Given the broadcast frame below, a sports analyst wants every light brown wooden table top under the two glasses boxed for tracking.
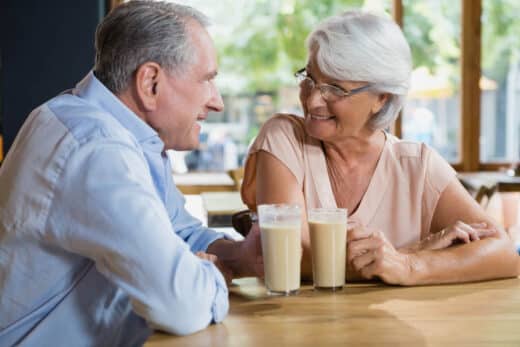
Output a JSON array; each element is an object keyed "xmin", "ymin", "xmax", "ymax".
[{"xmin": 145, "ymin": 278, "xmax": 520, "ymax": 347}]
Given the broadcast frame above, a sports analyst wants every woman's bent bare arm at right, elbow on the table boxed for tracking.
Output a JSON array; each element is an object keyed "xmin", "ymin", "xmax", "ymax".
[{"xmin": 412, "ymin": 178, "xmax": 519, "ymax": 284}]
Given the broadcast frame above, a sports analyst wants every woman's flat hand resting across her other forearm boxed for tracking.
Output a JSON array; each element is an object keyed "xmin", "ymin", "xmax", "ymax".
[{"xmin": 406, "ymin": 221, "xmax": 498, "ymax": 252}]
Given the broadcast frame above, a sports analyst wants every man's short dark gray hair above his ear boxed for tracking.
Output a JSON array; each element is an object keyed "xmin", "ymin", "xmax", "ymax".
[{"xmin": 94, "ymin": 1, "xmax": 208, "ymax": 94}]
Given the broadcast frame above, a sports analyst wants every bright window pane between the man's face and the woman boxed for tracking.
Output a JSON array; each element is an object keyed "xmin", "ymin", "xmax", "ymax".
[{"xmin": 168, "ymin": 0, "xmax": 392, "ymax": 171}]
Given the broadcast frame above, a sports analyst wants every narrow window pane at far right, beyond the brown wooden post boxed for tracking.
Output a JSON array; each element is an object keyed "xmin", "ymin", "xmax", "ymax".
[{"xmin": 480, "ymin": 0, "xmax": 520, "ymax": 163}]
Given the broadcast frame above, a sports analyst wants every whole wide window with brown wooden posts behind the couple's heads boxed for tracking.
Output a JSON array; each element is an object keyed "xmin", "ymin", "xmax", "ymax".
[{"xmin": 116, "ymin": 0, "xmax": 520, "ymax": 171}]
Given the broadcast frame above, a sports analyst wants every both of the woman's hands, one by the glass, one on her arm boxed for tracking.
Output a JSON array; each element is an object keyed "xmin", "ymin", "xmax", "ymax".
[{"xmin": 347, "ymin": 221, "xmax": 498, "ymax": 285}]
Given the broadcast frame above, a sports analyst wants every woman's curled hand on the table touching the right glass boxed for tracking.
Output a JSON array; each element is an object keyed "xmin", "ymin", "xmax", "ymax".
[{"xmin": 347, "ymin": 226, "xmax": 413, "ymax": 285}]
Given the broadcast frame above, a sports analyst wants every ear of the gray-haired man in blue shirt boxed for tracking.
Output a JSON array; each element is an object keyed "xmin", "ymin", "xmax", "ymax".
[{"xmin": 135, "ymin": 62, "xmax": 161, "ymax": 111}]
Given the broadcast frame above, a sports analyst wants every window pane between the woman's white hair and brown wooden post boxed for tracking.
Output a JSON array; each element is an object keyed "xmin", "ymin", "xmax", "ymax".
[{"xmin": 402, "ymin": 0, "xmax": 461, "ymax": 163}]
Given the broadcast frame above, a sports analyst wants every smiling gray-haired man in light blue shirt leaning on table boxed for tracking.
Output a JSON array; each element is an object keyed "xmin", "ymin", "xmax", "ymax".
[{"xmin": 0, "ymin": 1, "xmax": 262, "ymax": 346}]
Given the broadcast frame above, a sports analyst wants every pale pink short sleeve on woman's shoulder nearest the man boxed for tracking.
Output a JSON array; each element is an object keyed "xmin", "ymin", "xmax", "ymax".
[{"xmin": 241, "ymin": 114, "xmax": 305, "ymax": 210}]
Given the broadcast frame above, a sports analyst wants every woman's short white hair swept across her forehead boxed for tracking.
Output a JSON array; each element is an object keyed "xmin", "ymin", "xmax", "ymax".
[{"xmin": 307, "ymin": 11, "xmax": 412, "ymax": 129}]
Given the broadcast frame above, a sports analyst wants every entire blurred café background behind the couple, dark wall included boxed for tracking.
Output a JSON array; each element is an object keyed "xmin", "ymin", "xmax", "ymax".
[{"xmin": 0, "ymin": 0, "xmax": 520, "ymax": 231}]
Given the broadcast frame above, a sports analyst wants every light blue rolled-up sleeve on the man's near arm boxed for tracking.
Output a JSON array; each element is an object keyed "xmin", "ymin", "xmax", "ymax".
[{"xmin": 46, "ymin": 140, "xmax": 229, "ymax": 335}]
